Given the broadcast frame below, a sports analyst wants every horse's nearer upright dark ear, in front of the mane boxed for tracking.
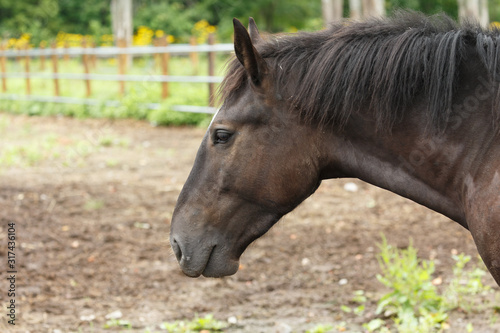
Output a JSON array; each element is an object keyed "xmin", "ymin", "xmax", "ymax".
[{"xmin": 233, "ymin": 18, "xmax": 267, "ymax": 86}]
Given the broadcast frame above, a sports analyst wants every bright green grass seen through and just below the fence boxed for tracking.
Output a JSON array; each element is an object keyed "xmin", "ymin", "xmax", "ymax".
[{"xmin": 0, "ymin": 55, "xmax": 228, "ymax": 125}]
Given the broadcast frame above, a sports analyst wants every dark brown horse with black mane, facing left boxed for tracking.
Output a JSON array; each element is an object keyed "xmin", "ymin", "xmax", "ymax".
[{"xmin": 170, "ymin": 13, "xmax": 500, "ymax": 283}]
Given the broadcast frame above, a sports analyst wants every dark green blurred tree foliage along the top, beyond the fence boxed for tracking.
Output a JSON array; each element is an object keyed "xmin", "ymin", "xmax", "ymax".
[{"xmin": 4, "ymin": 0, "xmax": 500, "ymax": 44}]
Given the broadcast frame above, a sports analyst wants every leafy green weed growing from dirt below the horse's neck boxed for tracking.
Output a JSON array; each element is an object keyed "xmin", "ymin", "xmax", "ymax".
[{"xmin": 372, "ymin": 237, "xmax": 488, "ymax": 333}]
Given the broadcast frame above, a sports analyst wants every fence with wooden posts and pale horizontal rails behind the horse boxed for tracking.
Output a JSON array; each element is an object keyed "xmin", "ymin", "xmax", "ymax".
[{"xmin": 0, "ymin": 35, "xmax": 234, "ymax": 113}]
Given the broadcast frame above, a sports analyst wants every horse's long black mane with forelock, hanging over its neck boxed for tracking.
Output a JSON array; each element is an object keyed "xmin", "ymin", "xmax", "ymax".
[{"xmin": 220, "ymin": 12, "xmax": 500, "ymax": 128}]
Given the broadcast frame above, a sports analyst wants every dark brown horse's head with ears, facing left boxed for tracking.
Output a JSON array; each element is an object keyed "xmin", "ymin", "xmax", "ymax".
[{"xmin": 170, "ymin": 19, "xmax": 321, "ymax": 277}]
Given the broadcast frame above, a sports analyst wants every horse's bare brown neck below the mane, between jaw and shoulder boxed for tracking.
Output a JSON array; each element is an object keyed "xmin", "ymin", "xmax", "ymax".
[{"xmin": 327, "ymin": 103, "xmax": 500, "ymax": 227}]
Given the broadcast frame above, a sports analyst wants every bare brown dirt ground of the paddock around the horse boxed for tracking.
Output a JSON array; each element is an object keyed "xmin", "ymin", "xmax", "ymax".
[{"xmin": 0, "ymin": 113, "xmax": 500, "ymax": 333}]
